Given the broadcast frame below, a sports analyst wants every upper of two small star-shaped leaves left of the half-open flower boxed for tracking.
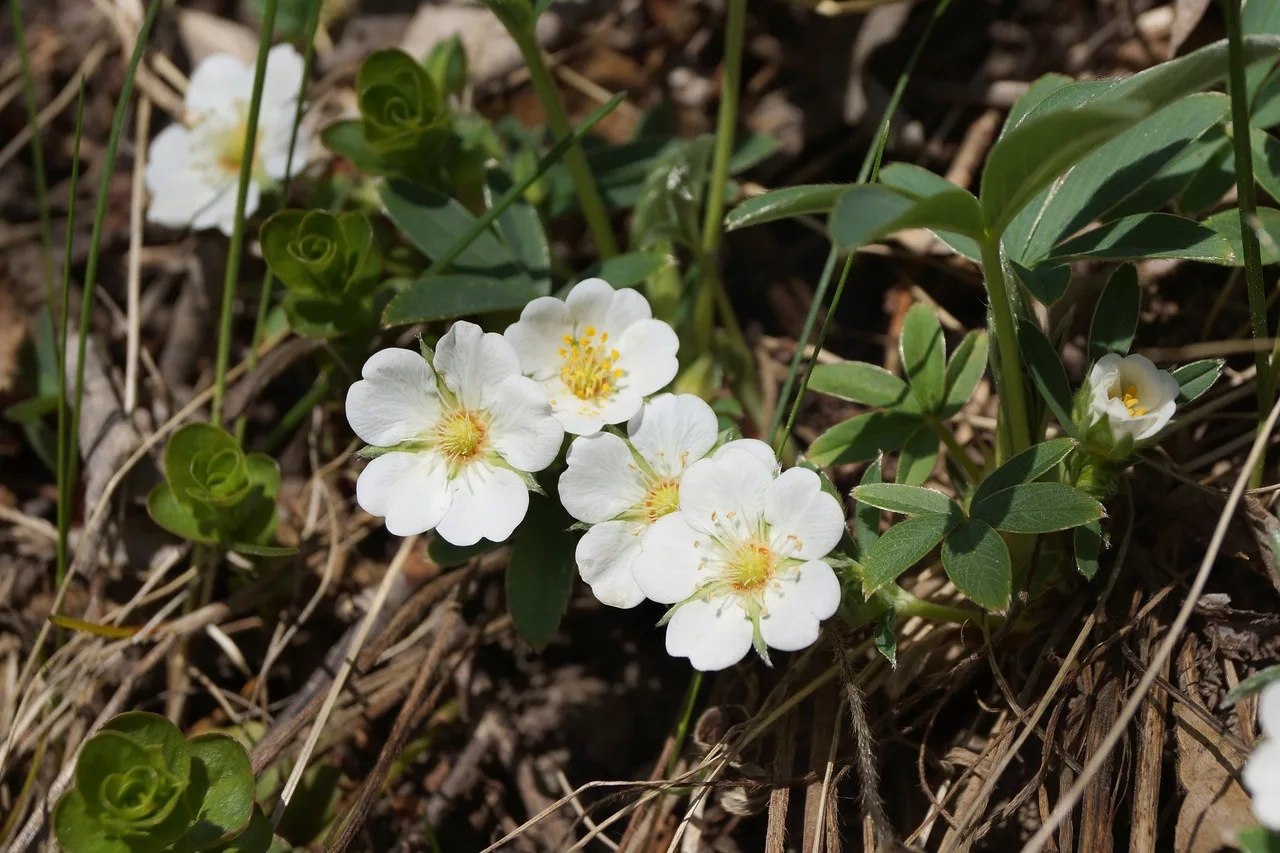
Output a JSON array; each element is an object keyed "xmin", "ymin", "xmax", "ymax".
[{"xmin": 809, "ymin": 305, "xmax": 987, "ymax": 485}]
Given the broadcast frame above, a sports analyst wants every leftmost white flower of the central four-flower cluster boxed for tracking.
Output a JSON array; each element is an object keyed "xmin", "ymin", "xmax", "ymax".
[{"xmin": 347, "ymin": 323, "xmax": 564, "ymax": 546}]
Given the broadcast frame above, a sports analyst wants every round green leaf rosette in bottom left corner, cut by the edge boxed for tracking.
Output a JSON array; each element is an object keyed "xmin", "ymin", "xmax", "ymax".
[{"xmin": 54, "ymin": 711, "xmax": 264, "ymax": 853}]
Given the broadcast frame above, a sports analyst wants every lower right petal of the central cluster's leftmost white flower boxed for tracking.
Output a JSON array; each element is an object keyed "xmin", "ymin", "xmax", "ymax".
[{"xmin": 435, "ymin": 462, "xmax": 529, "ymax": 546}]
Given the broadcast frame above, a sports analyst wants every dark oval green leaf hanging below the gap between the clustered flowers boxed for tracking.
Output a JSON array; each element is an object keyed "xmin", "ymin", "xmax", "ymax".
[{"xmin": 507, "ymin": 494, "xmax": 576, "ymax": 649}]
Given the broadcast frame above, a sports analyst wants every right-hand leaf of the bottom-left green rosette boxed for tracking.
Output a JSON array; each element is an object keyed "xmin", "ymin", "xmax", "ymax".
[{"xmin": 173, "ymin": 734, "xmax": 253, "ymax": 853}]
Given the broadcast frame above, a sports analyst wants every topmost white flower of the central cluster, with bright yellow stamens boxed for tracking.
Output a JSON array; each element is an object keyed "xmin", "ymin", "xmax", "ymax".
[{"xmin": 506, "ymin": 278, "xmax": 680, "ymax": 435}]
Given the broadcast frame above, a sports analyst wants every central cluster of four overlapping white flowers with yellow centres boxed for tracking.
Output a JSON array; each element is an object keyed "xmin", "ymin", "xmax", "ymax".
[{"xmin": 347, "ymin": 279, "xmax": 845, "ymax": 670}]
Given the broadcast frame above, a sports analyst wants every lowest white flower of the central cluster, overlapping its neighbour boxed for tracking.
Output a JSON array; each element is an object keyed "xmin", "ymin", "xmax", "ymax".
[{"xmin": 634, "ymin": 439, "xmax": 845, "ymax": 670}]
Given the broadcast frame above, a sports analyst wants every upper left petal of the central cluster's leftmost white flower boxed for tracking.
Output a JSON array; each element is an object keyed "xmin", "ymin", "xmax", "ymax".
[{"xmin": 347, "ymin": 348, "xmax": 440, "ymax": 447}]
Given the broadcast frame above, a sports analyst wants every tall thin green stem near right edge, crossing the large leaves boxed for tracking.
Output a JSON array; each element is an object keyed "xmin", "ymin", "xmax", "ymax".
[{"xmin": 1222, "ymin": 0, "xmax": 1276, "ymax": 488}]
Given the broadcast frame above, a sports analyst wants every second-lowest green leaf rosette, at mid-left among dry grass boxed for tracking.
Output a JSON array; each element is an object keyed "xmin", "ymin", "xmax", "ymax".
[{"xmin": 147, "ymin": 424, "xmax": 285, "ymax": 556}]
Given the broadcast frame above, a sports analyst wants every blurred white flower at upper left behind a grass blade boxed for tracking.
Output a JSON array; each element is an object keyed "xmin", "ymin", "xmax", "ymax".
[{"xmin": 146, "ymin": 45, "xmax": 306, "ymax": 234}]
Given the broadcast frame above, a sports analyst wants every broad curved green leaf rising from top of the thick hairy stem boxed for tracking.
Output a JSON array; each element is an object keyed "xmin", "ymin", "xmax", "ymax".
[{"xmin": 978, "ymin": 104, "xmax": 1143, "ymax": 234}]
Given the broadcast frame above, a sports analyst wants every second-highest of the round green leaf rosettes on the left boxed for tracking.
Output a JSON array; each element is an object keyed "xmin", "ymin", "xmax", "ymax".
[{"xmin": 260, "ymin": 210, "xmax": 381, "ymax": 338}]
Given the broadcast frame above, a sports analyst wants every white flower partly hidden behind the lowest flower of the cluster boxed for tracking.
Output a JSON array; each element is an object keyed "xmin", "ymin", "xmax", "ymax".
[{"xmin": 559, "ymin": 394, "xmax": 719, "ymax": 607}]
